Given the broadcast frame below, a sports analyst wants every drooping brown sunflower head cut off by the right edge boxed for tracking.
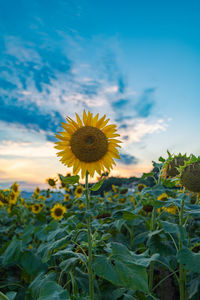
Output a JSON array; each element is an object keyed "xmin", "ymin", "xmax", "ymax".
[{"xmin": 179, "ymin": 155, "xmax": 200, "ymax": 193}]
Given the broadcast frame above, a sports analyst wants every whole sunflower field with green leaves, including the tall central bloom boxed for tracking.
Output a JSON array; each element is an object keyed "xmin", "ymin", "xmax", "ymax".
[{"xmin": 0, "ymin": 113, "xmax": 200, "ymax": 300}]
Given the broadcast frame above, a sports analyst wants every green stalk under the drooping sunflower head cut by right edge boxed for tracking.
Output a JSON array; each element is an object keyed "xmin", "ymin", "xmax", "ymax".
[{"xmin": 179, "ymin": 199, "xmax": 185, "ymax": 300}]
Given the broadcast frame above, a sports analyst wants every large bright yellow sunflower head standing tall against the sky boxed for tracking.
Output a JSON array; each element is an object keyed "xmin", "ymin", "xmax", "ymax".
[{"xmin": 55, "ymin": 110, "xmax": 120, "ymax": 178}]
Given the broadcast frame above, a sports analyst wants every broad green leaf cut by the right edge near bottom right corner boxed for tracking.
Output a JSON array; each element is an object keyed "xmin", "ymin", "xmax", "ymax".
[{"xmin": 177, "ymin": 248, "xmax": 200, "ymax": 274}]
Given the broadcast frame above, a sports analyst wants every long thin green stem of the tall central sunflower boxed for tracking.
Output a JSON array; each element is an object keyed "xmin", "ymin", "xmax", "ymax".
[{"xmin": 85, "ymin": 171, "xmax": 94, "ymax": 300}]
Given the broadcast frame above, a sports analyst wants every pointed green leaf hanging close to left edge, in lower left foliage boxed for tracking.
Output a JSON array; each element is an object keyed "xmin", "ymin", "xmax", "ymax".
[{"xmin": 2, "ymin": 236, "xmax": 21, "ymax": 266}]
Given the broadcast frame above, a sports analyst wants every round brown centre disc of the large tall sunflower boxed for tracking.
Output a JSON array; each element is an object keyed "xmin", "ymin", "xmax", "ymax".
[{"xmin": 70, "ymin": 126, "xmax": 108, "ymax": 162}]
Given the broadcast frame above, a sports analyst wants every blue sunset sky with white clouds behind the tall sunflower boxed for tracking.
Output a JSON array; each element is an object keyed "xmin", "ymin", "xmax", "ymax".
[{"xmin": 0, "ymin": 0, "xmax": 200, "ymax": 189}]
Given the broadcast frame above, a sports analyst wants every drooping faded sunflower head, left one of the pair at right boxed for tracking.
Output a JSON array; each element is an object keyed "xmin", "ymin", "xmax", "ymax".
[{"xmin": 161, "ymin": 152, "xmax": 189, "ymax": 179}]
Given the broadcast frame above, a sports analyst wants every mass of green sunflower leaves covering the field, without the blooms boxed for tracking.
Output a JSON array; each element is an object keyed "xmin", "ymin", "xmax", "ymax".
[{"xmin": 0, "ymin": 163, "xmax": 200, "ymax": 300}]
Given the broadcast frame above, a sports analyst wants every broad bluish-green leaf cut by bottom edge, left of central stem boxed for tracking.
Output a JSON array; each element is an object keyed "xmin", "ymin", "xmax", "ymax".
[{"xmin": 38, "ymin": 281, "xmax": 70, "ymax": 300}]
